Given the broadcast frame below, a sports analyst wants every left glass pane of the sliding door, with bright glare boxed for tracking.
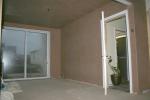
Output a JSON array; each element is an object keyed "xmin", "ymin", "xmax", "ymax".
[{"xmin": 2, "ymin": 29, "xmax": 25, "ymax": 79}]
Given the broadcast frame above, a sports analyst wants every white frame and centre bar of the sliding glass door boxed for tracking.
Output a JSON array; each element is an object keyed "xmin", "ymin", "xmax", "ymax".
[{"xmin": 3, "ymin": 26, "xmax": 51, "ymax": 81}]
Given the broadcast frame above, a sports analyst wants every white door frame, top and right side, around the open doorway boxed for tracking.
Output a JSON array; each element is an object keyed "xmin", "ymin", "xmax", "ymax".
[{"xmin": 102, "ymin": 10, "xmax": 133, "ymax": 94}]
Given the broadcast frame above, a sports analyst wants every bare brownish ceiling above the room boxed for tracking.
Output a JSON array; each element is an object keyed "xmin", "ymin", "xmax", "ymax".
[{"xmin": 4, "ymin": 0, "xmax": 111, "ymax": 27}]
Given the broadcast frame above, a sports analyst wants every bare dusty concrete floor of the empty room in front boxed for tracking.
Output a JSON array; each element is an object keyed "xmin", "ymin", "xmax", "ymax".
[{"xmin": 15, "ymin": 79, "xmax": 150, "ymax": 100}]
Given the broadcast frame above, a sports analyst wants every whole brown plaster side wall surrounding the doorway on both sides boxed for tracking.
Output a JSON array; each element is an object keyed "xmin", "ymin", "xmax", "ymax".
[{"xmin": 61, "ymin": 0, "xmax": 150, "ymax": 93}]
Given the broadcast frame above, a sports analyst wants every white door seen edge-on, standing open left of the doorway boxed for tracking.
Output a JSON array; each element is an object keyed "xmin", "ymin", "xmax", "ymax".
[{"xmin": 101, "ymin": 11, "xmax": 108, "ymax": 95}]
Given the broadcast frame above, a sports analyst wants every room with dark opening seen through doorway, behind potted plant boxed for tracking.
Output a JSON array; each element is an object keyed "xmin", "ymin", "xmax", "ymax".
[{"xmin": 106, "ymin": 16, "xmax": 129, "ymax": 91}]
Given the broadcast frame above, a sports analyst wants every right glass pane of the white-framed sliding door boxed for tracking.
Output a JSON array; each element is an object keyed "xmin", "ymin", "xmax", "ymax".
[{"xmin": 26, "ymin": 32, "xmax": 47, "ymax": 78}]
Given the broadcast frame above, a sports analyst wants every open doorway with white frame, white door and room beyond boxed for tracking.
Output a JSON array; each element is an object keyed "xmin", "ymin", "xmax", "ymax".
[{"xmin": 101, "ymin": 10, "xmax": 133, "ymax": 94}]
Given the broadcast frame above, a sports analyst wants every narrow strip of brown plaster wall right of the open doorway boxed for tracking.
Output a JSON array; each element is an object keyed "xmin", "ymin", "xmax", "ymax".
[{"xmin": 130, "ymin": 0, "xmax": 150, "ymax": 92}]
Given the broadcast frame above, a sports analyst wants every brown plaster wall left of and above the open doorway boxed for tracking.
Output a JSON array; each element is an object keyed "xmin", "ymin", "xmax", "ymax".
[{"xmin": 62, "ymin": 2, "xmax": 125, "ymax": 85}]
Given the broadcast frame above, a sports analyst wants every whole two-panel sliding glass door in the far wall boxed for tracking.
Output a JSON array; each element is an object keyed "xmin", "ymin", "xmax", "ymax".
[{"xmin": 2, "ymin": 28, "xmax": 49, "ymax": 79}]
